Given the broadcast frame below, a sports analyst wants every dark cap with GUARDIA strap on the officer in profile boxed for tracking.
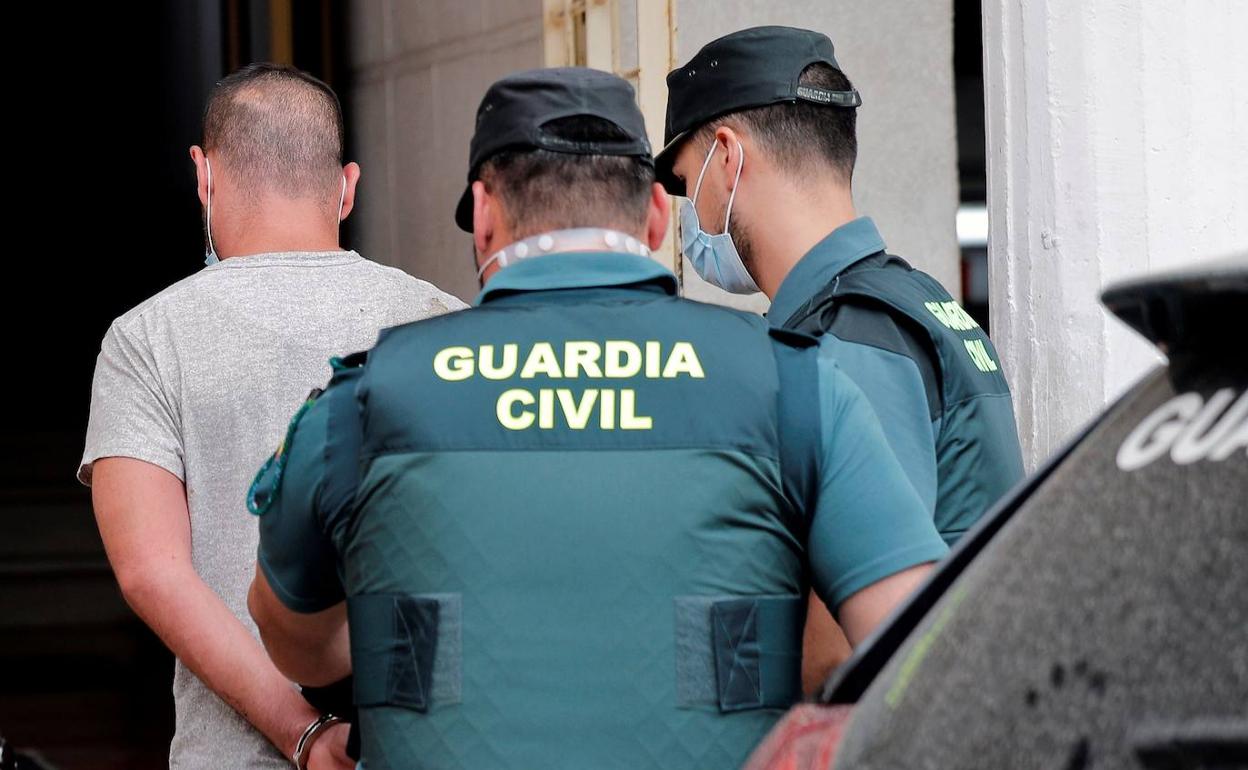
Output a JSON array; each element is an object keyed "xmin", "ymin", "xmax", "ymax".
[{"xmin": 654, "ymin": 26, "xmax": 862, "ymax": 195}]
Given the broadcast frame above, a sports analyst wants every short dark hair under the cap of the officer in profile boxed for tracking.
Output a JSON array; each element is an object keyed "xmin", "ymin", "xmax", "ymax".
[{"xmin": 698, "ymin": 62, "xmax": 857, "ymax": 185}]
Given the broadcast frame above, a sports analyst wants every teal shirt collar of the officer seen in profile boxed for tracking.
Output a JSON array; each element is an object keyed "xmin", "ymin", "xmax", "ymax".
[{"xmin": 768, "ymin": 217, "xmax": 885, "ymax": 326}]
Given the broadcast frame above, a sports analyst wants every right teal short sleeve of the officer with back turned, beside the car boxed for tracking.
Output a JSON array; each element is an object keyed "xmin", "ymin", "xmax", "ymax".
[{"xmin": 809, "ymin": 356, "xmax": 947, "ymax": 608}]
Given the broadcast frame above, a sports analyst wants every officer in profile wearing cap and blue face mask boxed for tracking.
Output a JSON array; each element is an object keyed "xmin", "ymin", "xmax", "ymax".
[{"xmin": 655, "ymin": 26, "xmax": 1022, "ymax": 686}]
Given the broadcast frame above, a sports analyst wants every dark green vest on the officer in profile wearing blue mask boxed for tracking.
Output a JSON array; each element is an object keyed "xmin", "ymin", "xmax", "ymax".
[{"xmin": 784, "ymin": 252, "xmax": 1023, "ymax": 539}]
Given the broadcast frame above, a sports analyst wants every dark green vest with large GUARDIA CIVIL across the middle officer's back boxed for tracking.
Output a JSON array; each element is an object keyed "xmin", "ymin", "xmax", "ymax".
[{"xmin": 342, "ymin": 288, "xmax": 814, "ymax": 770}]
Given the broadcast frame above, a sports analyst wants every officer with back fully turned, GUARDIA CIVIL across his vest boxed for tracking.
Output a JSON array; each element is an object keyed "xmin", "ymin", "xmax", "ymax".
[{"xmin": 250, "ymin": 69, "xmax": 945, "ymax": 770}]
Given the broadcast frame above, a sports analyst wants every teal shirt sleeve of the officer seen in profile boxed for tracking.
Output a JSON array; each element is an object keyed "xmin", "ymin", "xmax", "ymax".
[{"xmin": 820, "ymin": 334, "xmax": 937, "ymax": 517}]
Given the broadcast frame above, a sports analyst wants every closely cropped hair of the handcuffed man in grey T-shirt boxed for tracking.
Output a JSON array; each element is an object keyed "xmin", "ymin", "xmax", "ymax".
[{"xmin": 203, "ymin": 62, "xmax": 343, "ymax": 197}]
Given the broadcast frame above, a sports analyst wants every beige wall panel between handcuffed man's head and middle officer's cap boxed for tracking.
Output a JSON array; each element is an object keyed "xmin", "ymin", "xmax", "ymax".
[{"xmin": 348, "ymin": 0, "xmax": 542, "ymax": 300}]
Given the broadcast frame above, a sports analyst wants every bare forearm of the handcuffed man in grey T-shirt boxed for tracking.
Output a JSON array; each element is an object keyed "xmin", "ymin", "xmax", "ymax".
[{"xmin": 119, "ymin": 565, "xmax": 317, "ymax": 756}]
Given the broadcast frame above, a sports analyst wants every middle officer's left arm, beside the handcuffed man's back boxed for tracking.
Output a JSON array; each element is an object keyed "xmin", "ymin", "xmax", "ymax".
[{"xmin": 247, "ymin": 382, "xmax": 353, "ymax": 686}]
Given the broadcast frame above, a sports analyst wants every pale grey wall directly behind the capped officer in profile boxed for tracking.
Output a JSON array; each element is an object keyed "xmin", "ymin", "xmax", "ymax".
[{"xmin": 676, "ymin": 0, "xmax": 961, "ymax": 312}]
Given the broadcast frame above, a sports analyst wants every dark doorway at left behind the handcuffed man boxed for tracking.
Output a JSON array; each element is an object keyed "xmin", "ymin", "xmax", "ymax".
[{"xmin": 0, "ymin": 0, "xmax": 346, "ymax": 770}]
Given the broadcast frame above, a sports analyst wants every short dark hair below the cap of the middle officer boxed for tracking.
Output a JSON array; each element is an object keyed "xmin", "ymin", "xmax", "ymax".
[{"xmin": 479, "ymin": 116, "xmax": 654, "ymax": 238}]
